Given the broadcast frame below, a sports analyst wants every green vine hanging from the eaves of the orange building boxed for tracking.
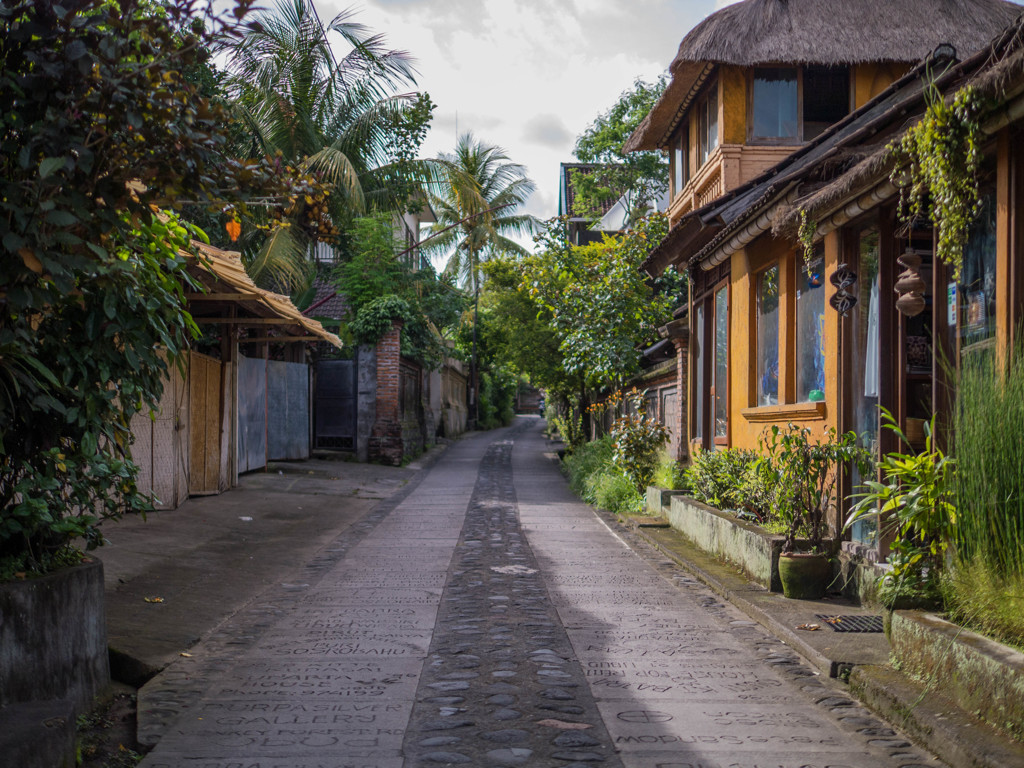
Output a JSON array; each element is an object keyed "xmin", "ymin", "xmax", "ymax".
[{"xmin": 889, "ymin": 83, "xmax": 983, "ymax": 281}]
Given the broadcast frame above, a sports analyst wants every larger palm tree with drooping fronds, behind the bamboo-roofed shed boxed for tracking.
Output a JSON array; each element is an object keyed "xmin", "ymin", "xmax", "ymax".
[{"xmin": 227, "ymin": 0, "xmax": 429, "ymax": 289}]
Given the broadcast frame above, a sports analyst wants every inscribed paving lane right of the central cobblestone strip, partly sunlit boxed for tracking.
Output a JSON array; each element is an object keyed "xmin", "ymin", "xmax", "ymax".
[{"xmin": 513, "ymin": 417, "xmax": 938, "ymax": 768}]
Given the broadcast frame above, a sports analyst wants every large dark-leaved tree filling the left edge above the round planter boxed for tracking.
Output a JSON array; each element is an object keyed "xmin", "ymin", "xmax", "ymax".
[{"xmin": 0, "ymin": 0, "xmax": 272, "ymax": 569}]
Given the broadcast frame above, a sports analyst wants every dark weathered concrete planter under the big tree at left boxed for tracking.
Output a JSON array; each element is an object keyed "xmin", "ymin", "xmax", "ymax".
[{"xmin": 0, "ymin": 559, "xmax": 111, "ymax": 713}]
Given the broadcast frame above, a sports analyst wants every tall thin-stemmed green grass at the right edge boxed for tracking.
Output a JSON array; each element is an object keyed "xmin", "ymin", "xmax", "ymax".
[{"xmin": 952, "ymin": 343, "xmax": 1024, "ymax": 579}]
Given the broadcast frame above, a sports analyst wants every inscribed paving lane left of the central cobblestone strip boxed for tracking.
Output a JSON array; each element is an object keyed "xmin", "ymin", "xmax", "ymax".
[{"xmin": 140, "ymin": 435, "xmax": 493, "ymax": 768}]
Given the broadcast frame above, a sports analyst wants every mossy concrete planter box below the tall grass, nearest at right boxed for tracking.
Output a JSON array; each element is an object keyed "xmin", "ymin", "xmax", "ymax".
[{"xmin": 889, "ymin": 610, "xmax": 1024, "ymax": 741}]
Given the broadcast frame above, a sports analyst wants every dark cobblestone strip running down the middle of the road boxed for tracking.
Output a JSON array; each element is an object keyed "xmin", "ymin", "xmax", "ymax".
[{"xmin": 404, "ymin": 428, "xmax": 622, "ymax": 768}]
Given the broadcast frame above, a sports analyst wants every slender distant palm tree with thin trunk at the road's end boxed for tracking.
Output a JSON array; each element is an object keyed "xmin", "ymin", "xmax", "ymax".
[{"xmin": 423, "ymin": 133, "xmax": 540, "ymax": 430}]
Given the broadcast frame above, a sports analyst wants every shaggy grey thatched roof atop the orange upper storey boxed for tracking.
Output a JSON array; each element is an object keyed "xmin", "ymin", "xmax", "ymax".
[{"xmin": 626, "ymin": 0, "xmax": 1024, "ymax": 152}]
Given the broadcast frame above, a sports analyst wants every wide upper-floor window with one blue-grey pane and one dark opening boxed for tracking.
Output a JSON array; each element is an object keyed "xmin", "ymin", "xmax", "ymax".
[{"xmin": 749, "ymin": 67, "xmax": 850, "ymax": 142}]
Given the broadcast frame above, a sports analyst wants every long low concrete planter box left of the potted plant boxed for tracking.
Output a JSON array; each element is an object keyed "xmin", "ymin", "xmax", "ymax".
[{"xmin": 668, "ymin": 496, "xmax": 833, "ymax": 592}]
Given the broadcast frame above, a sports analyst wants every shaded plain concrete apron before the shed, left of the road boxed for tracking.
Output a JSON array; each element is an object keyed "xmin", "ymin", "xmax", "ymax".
[{"xmin": 95, "ymin": 445, "xmax": 444, "ymax": 687}]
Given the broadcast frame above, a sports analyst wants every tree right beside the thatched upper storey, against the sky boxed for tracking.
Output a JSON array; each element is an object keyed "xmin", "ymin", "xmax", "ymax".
[{"xmin": 571, "ymin": 75, "xmax": 669, "ymax": 222}]
